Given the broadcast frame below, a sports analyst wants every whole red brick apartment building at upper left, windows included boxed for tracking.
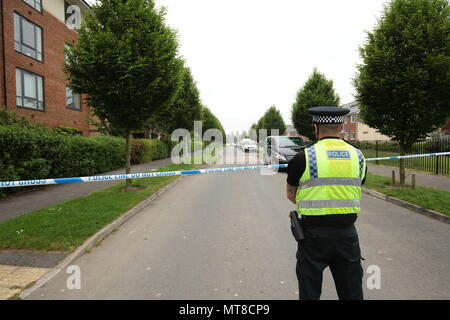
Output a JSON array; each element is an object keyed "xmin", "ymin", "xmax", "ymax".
[{"xmin": 0, "ymin": 0, "xmax": 96, "ymax": 136}]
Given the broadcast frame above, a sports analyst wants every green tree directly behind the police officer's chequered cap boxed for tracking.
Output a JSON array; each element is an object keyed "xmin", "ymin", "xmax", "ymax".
[{"xmin": 291, "ymin": 68, "xmax": 340, "ymax": 140}]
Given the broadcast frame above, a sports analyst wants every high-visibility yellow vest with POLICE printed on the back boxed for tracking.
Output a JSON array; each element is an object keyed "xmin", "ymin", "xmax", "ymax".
[{"xmin": 296, "ymin": 138, "xmax": 366, "ymax": 216}]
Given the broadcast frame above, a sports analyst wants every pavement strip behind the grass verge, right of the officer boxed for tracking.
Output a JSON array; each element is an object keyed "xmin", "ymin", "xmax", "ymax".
[{"xmin": 367, "ymin": 164, "xmax": 450, "ymax": 192}]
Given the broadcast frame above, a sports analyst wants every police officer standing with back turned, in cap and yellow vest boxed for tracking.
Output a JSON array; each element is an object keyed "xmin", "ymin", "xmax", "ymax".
[{"xmin": 287, "ymin": 107, "xmax": 367, "ymax": 300}]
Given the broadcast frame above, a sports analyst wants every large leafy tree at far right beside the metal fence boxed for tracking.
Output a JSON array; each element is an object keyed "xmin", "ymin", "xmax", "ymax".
[{"xmin": 354, "ymin": 0, "xmax": 450, "ymax": 187}]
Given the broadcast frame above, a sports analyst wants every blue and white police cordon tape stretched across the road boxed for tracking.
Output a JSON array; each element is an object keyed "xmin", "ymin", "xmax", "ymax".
[{"xmin": 0, "ymin": 152, "xmax": 450, "ymax": 188}]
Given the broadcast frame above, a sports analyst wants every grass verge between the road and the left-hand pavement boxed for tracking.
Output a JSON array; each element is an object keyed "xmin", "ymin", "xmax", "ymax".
[{"xmin": 0, "ymin": 164, "xmax": 195, "ymax": 252}]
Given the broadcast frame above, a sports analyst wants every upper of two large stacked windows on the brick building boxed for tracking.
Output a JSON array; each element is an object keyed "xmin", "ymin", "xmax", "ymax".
[{"xmin": 14, "ymin": 13, "xmax": 42, "ymax": 61}]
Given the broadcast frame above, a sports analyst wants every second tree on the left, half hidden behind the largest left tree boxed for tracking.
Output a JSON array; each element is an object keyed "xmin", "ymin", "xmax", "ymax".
[{"xmin": 150, "ymin": 67, "xmax": 202, "ymax": 135}]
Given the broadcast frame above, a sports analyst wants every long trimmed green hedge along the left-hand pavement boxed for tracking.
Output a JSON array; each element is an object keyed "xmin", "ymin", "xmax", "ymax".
[{"xmin": 0, "ymin": 125, "xmax": 176, "ymax": 196}]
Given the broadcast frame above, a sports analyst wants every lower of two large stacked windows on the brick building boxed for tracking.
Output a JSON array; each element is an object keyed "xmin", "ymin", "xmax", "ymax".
[{"xmin": 16, "ymin": 68, "xmax": 44, "ymax": 111}]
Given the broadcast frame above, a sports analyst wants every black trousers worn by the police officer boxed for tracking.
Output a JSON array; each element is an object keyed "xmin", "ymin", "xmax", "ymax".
[{"xmin": 296, "ymin": 225, "xmax": 363, "ymax": 300}]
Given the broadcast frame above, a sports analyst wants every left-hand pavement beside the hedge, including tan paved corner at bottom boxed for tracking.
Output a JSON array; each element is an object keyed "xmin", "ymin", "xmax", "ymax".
[{"xmin": 0, "ymin": 158, "xmax": 172, "ymax": 300}]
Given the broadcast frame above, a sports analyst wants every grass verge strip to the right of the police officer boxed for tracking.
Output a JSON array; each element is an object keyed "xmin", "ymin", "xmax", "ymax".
[{"xmin": 364, "ymin": 172, "xmax": 450, "ymax": 216}]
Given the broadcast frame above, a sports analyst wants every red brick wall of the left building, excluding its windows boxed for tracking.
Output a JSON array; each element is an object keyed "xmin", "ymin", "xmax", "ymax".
[{"xmin": 2, "ymin": 0, "xmax": 93, "ymax": 136}]
